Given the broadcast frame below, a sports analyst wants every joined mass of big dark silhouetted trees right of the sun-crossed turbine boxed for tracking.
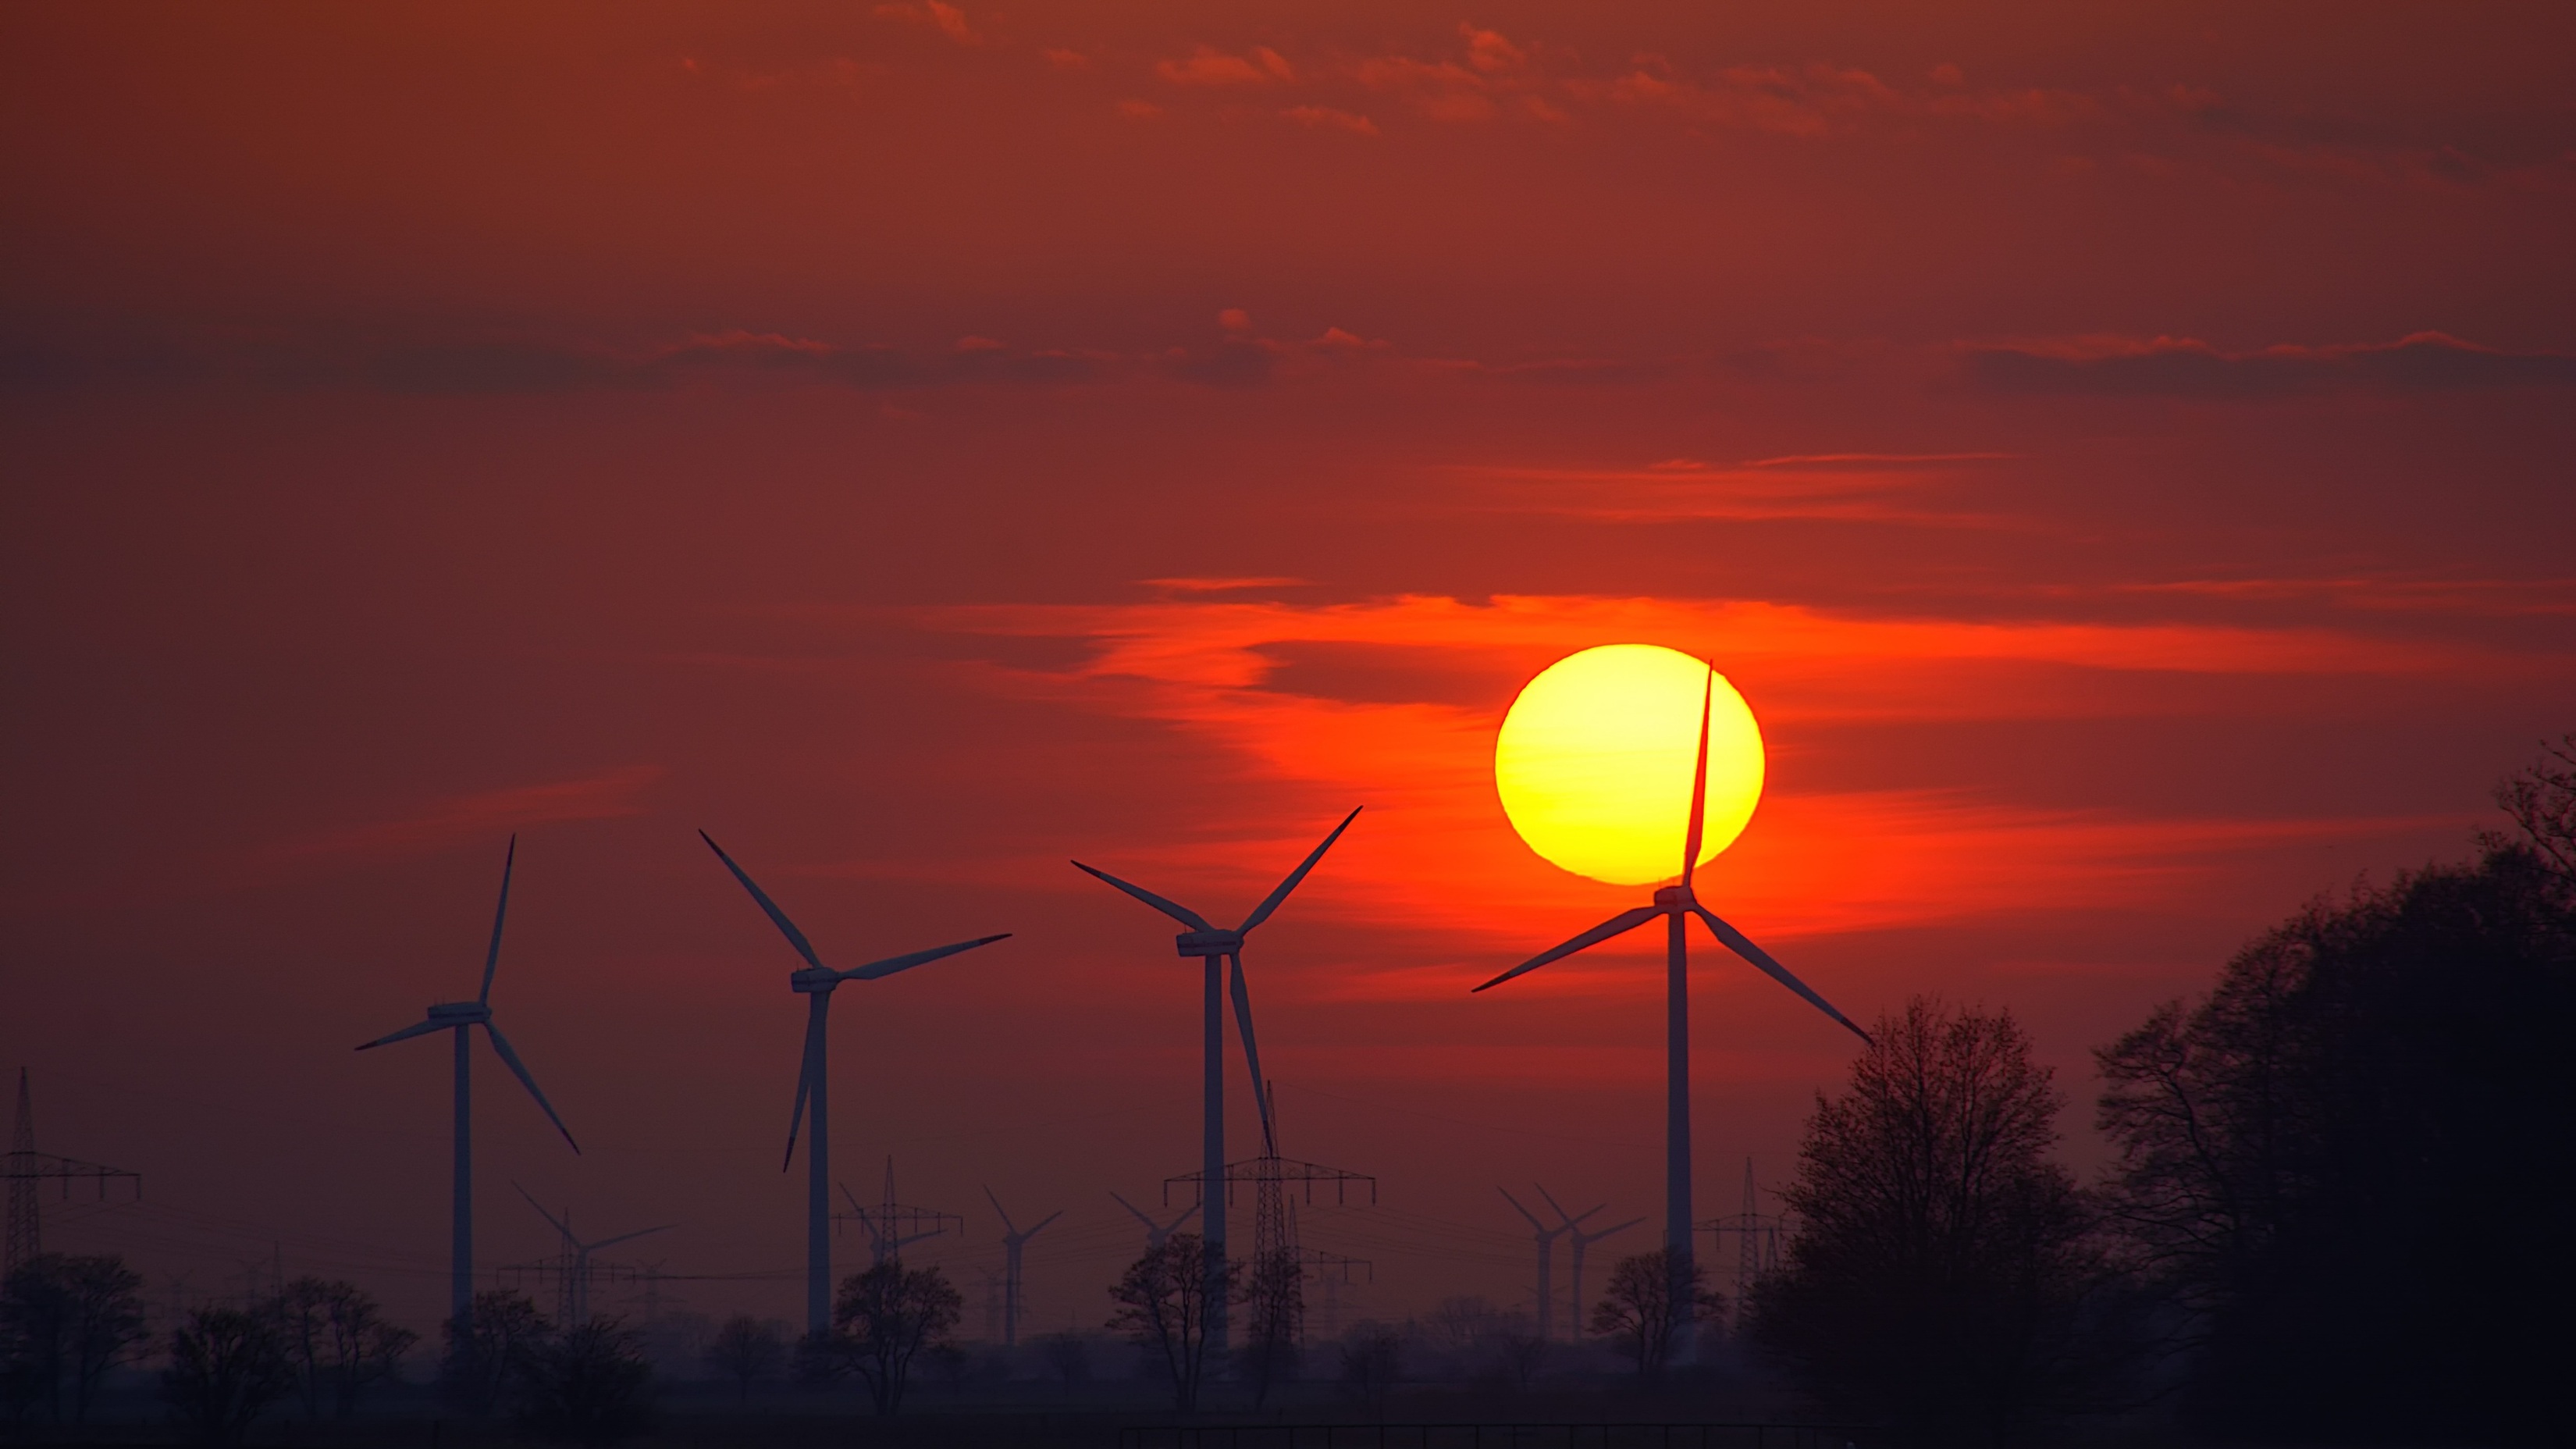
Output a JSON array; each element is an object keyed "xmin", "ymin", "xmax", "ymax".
[{"xmin": 1746, "ymin": 735, "xmax": 2576, "ymax": 1444}]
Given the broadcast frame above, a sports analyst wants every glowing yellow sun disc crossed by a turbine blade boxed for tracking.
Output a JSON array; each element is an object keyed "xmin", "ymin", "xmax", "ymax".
[{"xmin": 1494, "ymin": 645, "xmax": 1762, "ymax": 885}]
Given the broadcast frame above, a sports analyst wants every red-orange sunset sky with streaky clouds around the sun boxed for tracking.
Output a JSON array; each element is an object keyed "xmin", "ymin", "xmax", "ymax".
[{"xmin": 0, "ymin": 2, "xmax": 2576, "ymax": 1325}]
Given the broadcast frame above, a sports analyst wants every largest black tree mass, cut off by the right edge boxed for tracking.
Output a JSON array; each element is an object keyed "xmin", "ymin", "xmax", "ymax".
[{"xmin": 2100, "ymin": 824, "xmax": 2576, "ymax": 1441}]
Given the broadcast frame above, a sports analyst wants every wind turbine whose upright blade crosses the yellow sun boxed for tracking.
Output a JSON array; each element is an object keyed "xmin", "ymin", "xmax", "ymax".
[{"xmin": 1476, "ymin": 665, "xmax": 1870, "ymax": 1356}]
